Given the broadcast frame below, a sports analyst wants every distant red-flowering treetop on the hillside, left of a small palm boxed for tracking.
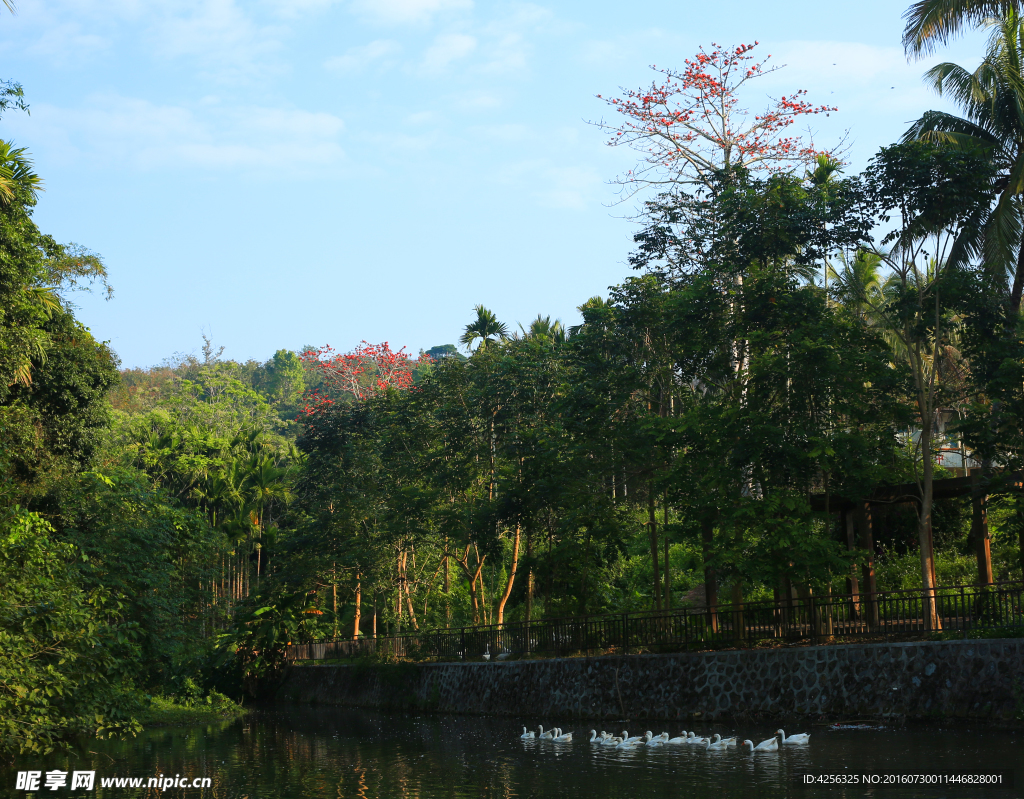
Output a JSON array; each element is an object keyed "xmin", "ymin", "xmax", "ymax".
[{"xmin": 302, "ymin": 341, "xmax": 428, "ymax": 416}]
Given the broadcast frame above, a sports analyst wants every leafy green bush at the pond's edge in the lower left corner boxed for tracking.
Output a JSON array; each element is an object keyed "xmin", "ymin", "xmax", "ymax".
[{"xmin": 0, "ymin": 507, "xmax": 139, "ymax": 756}]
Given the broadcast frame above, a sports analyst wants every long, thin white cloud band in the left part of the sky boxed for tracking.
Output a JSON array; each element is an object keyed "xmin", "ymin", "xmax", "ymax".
[{"xmin": 22, "ymin": 95, "xmax": 344, "ymax": 171}]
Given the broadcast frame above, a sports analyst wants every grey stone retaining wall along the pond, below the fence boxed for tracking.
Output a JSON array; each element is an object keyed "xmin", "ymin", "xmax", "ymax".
[{"xmin": 276, "ymin": 638, "xmax": 1024, "ymax": 722}]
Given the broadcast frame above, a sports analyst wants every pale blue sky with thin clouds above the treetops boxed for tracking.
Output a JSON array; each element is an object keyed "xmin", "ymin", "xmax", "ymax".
[{"xmin": 0, "ymin": 0, "xmax": 982, "ymax": 367}]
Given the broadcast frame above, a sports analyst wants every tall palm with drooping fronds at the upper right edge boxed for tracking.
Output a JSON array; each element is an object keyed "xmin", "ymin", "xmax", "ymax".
[{"xmin": 903, "ymin": 8, "xmax": 1024, "ymax": 318}]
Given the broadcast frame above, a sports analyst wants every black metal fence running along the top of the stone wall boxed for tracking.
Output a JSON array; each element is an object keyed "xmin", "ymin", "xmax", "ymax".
[{"xmin": 287, "ymin": 583, "xmax": 1024, "ymax": 661}]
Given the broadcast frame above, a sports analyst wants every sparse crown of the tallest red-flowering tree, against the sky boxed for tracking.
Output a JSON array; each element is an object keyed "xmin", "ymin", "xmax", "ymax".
[{"xmin": 596, "ymin": 42, "xmax": 836, "ymax": 195}]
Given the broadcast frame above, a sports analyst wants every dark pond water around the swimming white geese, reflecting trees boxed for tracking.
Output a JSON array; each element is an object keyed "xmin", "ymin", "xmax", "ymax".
[{"xmin": 0, "ymin": 707, "xmax": 1024, "ymax": 799}]
